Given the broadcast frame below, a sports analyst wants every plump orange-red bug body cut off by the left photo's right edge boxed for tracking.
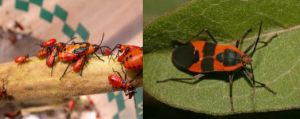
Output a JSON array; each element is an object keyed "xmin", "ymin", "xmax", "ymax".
[{"xmin": 121, "ymin": 48, "xmax": 143, "ymax": 69}]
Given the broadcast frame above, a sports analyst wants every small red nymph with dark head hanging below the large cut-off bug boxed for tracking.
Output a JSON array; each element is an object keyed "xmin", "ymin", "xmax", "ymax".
[{"xmin": 108, "ymin": 67, "xmax": 137, "ymax": 99}]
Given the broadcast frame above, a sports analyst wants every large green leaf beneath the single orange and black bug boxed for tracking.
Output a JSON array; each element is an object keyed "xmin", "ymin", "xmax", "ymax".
[{"xmin": 144, "ymin": 0, "xmax": 300, "ymax": 115}]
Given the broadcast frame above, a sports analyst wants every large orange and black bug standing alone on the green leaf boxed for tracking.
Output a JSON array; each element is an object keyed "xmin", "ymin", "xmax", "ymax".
[{"xmin": 157, "ymin": 22, "xmax": 276, "ymax": 111}]
